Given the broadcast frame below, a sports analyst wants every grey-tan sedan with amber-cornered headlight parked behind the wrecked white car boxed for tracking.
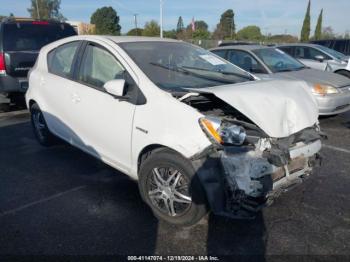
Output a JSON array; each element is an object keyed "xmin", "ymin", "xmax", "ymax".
[{"xmin": 211, "ymin": 45, "xmax": 350, "ymax": 115}]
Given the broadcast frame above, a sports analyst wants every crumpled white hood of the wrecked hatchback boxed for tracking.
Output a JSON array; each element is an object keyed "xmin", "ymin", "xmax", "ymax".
[{"xmin": 191, "ymin": 80, "xmax": 318, "ymax": 138}]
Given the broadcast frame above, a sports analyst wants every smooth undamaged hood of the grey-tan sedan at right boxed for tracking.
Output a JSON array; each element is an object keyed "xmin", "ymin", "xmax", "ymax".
[{"xmin": 274, "ymin": 69, "xmax": 350, "ymax": 88}]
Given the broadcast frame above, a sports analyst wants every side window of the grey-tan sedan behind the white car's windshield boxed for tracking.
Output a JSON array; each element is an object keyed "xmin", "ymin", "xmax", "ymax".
[{"xmin": 227, "ymin": 50, "xmax": 267, "ymax": 74}]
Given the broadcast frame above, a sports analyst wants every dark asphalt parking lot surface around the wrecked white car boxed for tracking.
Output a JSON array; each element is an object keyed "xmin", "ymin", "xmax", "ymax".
[{"xmin": 0, "ymin": 108, "xmax": 350, "ymax": 261}]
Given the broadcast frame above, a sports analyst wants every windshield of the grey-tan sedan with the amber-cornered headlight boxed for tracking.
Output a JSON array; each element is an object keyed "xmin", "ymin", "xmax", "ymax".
[{"xmin": 253, "ymin": 48, "xmax": 305, "ymax": 73}]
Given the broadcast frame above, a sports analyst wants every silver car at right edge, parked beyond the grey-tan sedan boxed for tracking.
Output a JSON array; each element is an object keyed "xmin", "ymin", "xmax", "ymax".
[{"xmin": 277, "ymin": 44, "xmax": 350, "ymax": 78}]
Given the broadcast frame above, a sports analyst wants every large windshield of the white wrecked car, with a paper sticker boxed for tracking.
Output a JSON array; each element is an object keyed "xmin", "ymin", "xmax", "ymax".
[{"xmin": 119, "ymin": 41, "xmax": 254, "ymax": 91}]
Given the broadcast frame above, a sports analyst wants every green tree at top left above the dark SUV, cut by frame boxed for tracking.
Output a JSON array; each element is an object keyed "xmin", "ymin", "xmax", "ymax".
[{"xmin": 27, "ymin": 0, "xmax": 66, "ymax": 20}]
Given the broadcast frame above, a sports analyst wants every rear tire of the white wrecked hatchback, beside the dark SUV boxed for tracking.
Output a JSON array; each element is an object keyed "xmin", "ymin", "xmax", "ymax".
[{"xmin": 30, "ymin": 104, "xmax": 56, "ymax": 147}]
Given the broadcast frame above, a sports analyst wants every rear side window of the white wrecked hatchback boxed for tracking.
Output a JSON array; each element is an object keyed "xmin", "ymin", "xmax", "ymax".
[{"xmin": 47, "ymin": 41, "xmax": 80, "ymax": 77}]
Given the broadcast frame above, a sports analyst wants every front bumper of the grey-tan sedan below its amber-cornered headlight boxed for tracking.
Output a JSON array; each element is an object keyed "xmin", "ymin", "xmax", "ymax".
[{"xmin": 316, "ymin": 91, "xmax": 350, "ymax": 115}]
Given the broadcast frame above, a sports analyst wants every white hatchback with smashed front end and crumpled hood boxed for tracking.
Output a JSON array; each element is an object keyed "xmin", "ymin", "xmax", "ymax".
[{"xmin": 26, "ymin": 36, "xmax": 321, "ymax": 225}]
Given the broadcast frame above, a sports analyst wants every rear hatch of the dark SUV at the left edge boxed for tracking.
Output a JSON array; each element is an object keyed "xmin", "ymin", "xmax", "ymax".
[{"xmin": 3, "ymin": 21, "xmax": 76, "ymax": 78}]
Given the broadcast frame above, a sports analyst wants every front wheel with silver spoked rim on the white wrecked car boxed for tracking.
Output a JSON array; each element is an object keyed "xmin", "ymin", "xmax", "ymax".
[{"xmin": 139, "ymin": 149, "xmax": 208, "ymax": 226}]
